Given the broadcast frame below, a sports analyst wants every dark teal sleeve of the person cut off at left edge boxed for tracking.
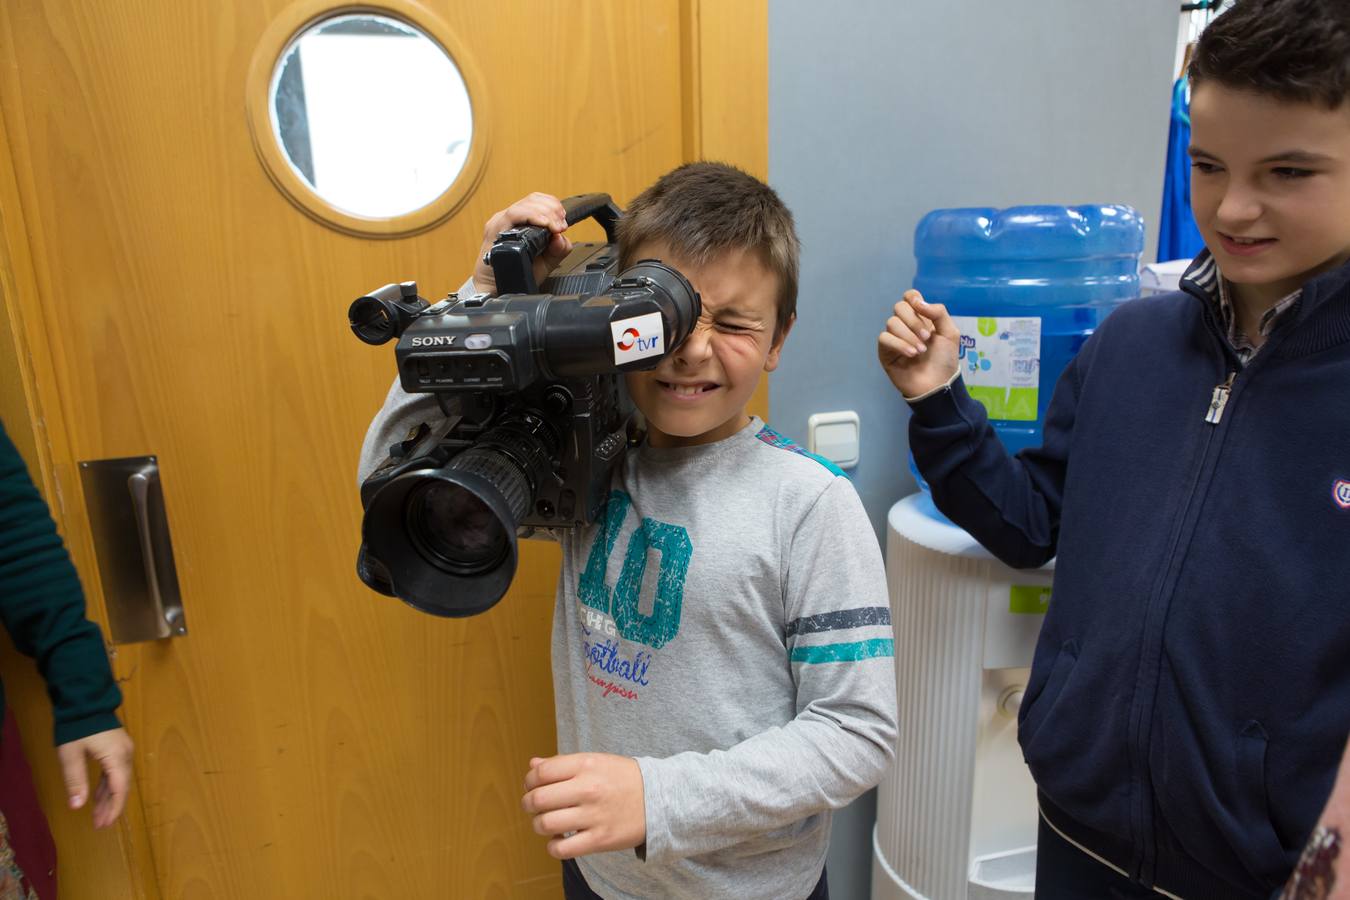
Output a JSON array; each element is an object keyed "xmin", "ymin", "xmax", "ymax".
[{"xmin": 0, "ymin": 425, "xmax": 122, "ymax": 743}]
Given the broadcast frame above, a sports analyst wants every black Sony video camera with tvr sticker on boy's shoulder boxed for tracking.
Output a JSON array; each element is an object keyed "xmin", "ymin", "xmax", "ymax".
[{"xmin": 347, "ymin": 194, "xmax": 702, "ymax": 617}]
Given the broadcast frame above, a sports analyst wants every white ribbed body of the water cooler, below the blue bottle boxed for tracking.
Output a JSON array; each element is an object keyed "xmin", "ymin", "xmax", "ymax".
[{"xmin": 872, "ymin": 494, "xmax": 1053, "ymax": 900}]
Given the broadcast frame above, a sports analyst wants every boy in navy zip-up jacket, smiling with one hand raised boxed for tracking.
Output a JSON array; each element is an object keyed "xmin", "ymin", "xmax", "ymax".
[{"xmin": 878, "ymin": 0, "xmax": 1350, "ymax": 900}]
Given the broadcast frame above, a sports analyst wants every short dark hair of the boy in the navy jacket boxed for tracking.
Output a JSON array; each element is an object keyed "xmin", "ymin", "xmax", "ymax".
[{"xmin": 1187, "ymin": 0, "xmax": 1350, "ymax": 109}]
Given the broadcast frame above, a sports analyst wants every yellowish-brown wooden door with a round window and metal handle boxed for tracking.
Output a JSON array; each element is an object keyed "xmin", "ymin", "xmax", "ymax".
[{"xmin": 0, "ymin": 0, "xmax": 767, "ymax": 900}]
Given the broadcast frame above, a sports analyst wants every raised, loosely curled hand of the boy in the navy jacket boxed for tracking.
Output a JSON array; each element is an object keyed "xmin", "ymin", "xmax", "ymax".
[{"xmin": 876, "ymin": 290, "xmax": 961, "ymax": 397}]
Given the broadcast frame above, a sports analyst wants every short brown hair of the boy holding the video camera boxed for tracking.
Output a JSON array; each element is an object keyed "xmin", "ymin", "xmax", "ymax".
[{"xmin": 618, "ymin": 162, "xmax": 801, "ymax": 337}]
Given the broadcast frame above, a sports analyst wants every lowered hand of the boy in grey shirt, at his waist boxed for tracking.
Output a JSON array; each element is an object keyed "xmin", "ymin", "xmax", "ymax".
[{"xmin": 520, "ymin": 753, "xmax": 647, "ymax": 860}]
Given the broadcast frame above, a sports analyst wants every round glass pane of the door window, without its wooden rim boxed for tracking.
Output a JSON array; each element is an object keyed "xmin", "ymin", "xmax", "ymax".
[{"xmin": 267, "ymin": 12, "xmax": 474, "ymax": 219}]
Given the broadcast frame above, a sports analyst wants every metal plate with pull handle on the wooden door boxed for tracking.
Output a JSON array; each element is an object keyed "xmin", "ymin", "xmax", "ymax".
[{"xmin": 80, "ymin": 456, "xmax": 188, "ymax": 644}]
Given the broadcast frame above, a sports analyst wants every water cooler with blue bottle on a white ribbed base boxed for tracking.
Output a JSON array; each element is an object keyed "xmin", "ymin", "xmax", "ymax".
[{"xmin": 872, "ymin": 206, "xmax": 1143, "ymax": 900}]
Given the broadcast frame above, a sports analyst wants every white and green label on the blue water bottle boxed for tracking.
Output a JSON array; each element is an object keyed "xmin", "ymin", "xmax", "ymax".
[{"xmin": 952, "ymin": 316, "xmax": 1041, "ymax": 422}]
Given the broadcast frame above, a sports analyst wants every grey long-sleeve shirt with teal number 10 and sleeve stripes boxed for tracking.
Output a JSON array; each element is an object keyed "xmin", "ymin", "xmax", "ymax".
[{"xmin": 362, "ymin": 385, "xmax": 895, "ymax": 900}]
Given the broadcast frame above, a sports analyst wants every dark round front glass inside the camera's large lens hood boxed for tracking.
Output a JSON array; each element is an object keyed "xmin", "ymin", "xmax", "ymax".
[{"xmin": 405, "ymin": 480, "xmax": 510, "ymax": 575}]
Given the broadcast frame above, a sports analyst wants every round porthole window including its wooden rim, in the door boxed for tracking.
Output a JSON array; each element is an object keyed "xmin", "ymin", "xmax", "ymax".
[{"xmin": 248, "ymin": 0, "xmax": 487, "ymax": 237}]
